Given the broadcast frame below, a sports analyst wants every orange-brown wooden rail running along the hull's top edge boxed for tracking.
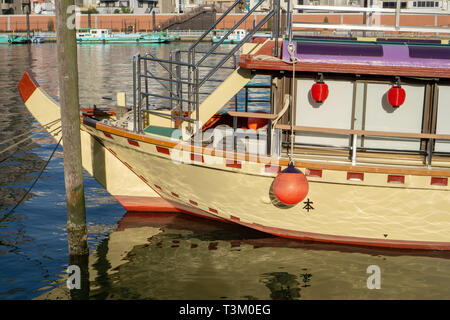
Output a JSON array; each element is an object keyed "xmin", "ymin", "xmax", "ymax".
[{"xmin": 81, "ymin": 117, "xmax": 450, "ymax": 177}]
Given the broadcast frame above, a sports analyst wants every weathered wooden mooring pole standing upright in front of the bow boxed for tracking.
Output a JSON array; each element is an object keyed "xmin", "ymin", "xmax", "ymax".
[{"xmin": 55, "ymin": 0, "xmax": 89, "ymax": 255}]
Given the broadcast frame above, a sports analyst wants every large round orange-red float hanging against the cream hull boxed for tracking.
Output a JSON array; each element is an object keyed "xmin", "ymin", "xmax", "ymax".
[{"xmin": 273, "ymin": 162, "xmax": 309, "ymax": 204}]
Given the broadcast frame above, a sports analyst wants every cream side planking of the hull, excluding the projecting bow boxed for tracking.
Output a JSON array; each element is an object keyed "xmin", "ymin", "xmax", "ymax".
[{"xmin": 81, "ymin": 120, "xmax": 450, "ymax": 249}]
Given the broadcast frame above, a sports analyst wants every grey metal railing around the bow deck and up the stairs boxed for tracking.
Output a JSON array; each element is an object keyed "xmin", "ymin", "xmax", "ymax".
[{"xmin": 133, "ymin": 0, "xmax": 286, "ymax": 133}]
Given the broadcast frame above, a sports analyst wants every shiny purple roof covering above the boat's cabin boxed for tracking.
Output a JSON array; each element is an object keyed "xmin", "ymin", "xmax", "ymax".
[{"xmin": 283, "ymin": 41, "xmax": 450, "ymax": 70}]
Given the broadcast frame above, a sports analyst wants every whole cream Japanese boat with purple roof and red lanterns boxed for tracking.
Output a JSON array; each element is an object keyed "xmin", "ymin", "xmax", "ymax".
[{"xmin": 19, "ymin": 1, "xmax": 450, "ymax": 250}]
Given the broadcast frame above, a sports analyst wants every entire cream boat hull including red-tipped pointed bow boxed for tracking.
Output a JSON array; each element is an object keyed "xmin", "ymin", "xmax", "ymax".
[{"xmin": 19, "ymin": 75, "xmax": 450, "ymax": 250}]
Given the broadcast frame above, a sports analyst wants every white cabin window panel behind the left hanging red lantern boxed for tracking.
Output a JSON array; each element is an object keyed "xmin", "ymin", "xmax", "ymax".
[{"xmin": 295, "ymin": 79, "xmax": 353, "ymax": 147}]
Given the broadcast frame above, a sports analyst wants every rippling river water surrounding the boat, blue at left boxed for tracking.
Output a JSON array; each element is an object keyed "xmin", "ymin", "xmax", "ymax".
[{"xmin": 0, "ymin": 43, "xmax": 450, "ymax": 300}]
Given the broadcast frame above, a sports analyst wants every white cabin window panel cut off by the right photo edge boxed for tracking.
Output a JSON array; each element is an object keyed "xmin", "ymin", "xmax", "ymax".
[{"xmin": 434, "ymin": 85, "xmax": 450, "ymax": 152}]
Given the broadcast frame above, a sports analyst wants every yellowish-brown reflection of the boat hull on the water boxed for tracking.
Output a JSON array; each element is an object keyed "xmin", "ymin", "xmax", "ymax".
[{"xmin": 40, "ymin": 213, "xmax": 450, "ymax": 300}]
